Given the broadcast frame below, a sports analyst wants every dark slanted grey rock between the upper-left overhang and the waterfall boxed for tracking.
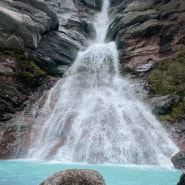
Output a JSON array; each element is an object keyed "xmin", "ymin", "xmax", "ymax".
[{"xmin": 26, "ymin": 1, "xmax": 95, "ymax": 76}]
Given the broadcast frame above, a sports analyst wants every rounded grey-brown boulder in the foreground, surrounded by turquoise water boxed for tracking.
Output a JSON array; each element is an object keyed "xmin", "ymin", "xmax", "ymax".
[{"xmin": 40, "ymin": 169, "xmax": 105, "ymax": 185}]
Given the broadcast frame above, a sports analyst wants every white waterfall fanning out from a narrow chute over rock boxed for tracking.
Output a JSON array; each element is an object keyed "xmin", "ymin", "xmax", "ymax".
[{"xmin": 27, "ymin": 0, "xmax": 177, "ymax": 165}]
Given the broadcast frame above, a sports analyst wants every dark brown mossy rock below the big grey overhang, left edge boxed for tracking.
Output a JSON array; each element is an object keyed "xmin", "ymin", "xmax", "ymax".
[{"xmin": 0, "ymin": 48, "xmax": 48, "ymax": 121}]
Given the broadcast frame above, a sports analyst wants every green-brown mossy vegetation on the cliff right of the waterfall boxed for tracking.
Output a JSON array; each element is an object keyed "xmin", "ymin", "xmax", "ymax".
[{"xmin": 148, "ymin": 50, "xmax": 185, "ymax": 121}]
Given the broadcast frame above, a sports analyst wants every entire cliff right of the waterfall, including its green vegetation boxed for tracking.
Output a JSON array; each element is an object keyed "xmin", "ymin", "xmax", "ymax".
[{"xmin": 107, "ymin": 0, "xmax": 185, "ymax": 165}]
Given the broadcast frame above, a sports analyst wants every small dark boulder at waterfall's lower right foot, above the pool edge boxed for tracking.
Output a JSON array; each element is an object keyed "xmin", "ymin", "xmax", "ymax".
[{"xmin": 171, "ymin": 151, "xmax": 185, "ymax": 170}]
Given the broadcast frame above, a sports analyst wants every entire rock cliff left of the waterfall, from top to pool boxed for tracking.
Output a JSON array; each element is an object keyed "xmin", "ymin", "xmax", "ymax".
[{"xmin": 0, "ymin": 0, "xmax": 101, "ymax": 159}]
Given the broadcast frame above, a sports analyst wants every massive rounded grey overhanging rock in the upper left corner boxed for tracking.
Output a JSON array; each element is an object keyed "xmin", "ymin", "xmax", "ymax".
[{"xmin": 0, "ymin": 0, "xmax": 59, "ymax": 50}]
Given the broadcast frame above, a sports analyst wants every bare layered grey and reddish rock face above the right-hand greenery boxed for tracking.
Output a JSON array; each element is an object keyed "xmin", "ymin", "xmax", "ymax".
[{"xmin": 107, "ymin": 0, "xmax": 185, "ymax": 70}]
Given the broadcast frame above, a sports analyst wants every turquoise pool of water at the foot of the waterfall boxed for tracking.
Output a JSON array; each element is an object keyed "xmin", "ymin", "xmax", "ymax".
[{"xmin": 0, "ymin": 160, "xmax": 182, "ymax": 185}]
